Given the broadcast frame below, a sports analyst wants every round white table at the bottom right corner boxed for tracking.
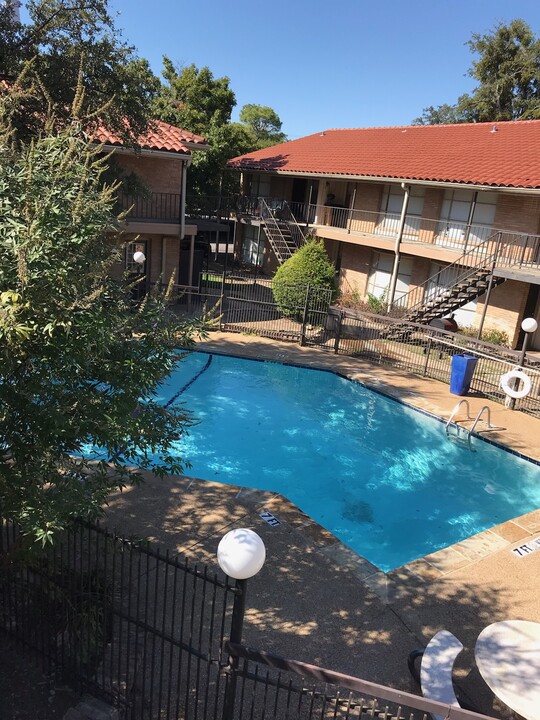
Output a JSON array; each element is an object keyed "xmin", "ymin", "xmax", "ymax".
[{"xmin": 474, "ymin": 620, "xmax": 540, "ymax": 720}]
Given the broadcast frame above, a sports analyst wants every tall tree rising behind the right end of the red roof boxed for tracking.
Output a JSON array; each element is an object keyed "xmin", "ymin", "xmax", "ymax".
[{"xmin": 414, "ymin": 19, "xmax": 540, "ymax": 125}]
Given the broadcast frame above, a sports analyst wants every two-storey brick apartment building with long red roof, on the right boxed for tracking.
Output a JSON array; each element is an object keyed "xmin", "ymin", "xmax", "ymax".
[{"xmin": 228, "ymin": 120, "xmax": 540, "ymax": 349}]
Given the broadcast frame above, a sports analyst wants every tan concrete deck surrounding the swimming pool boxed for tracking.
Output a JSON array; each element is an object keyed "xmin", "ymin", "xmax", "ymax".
[{"xmin": 104, "ymin": 333, "xmax": 540, "ymax": 715}]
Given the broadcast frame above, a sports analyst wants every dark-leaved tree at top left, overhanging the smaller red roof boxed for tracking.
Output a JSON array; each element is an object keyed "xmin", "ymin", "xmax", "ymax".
[{"xmin": 0, "ymin": 0, "xmax": 160, "ymax": 142}]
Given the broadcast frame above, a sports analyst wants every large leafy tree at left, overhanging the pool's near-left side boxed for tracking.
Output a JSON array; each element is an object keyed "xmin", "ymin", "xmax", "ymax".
[{"xmin": 0, "ymin": 85, "xmax": 202, "ymax": 541}]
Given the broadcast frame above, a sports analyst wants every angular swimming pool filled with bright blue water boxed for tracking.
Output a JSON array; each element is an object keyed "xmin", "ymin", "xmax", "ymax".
[{"xmin": 143, "ymin": 352, "xmax": 540, "ymax": 571}]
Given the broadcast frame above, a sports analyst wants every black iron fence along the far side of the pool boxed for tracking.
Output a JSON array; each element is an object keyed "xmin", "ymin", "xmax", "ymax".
[{"xmin": 165, "ymin": 273, "xmax": 540, "ymax": 415}]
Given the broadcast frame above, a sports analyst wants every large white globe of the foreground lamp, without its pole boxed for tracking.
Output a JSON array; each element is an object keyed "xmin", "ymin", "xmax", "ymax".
[{"xmin": 217, "ymin": 528, "xmax": 266, "ymax": 580}]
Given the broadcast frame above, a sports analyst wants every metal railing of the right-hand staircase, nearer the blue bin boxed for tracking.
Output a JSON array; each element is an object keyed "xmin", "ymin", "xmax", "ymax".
[{"xmin": 390, "ymin": 232, "xmax": 501, "ymax": 318}]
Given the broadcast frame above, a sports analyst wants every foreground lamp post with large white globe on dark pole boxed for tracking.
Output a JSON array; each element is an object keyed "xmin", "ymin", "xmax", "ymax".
[{"xmin": 217, "ymin": 528, "xmax": 266, "ymax": 720}]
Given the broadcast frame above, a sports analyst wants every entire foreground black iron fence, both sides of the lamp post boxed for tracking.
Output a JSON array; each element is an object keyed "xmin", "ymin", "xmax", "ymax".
[{"xmin": 0, "ymin": 521, "xmax": 498, "ymax": 720}]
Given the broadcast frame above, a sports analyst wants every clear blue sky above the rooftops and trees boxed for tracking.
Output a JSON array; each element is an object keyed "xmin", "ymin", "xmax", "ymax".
[{"xmin": 23, "ymin": 0, "xmax": 540, "ymax": 138}]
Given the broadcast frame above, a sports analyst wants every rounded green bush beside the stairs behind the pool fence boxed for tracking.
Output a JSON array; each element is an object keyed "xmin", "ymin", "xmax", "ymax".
[{"xmin": 272, "ymin": 237, "xmax": 337, "ymax": 319}]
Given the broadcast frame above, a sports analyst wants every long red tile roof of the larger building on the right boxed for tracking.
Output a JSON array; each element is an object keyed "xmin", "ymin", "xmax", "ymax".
[{"xmin": 228, "ymin": 120, "xmax": 540, "ymax": 188}]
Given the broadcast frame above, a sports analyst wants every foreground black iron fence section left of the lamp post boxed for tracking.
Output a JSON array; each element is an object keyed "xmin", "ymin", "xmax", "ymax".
[{"xmin": 0, "ymin": 522, "xmax": 243, "ymax": 720}]
